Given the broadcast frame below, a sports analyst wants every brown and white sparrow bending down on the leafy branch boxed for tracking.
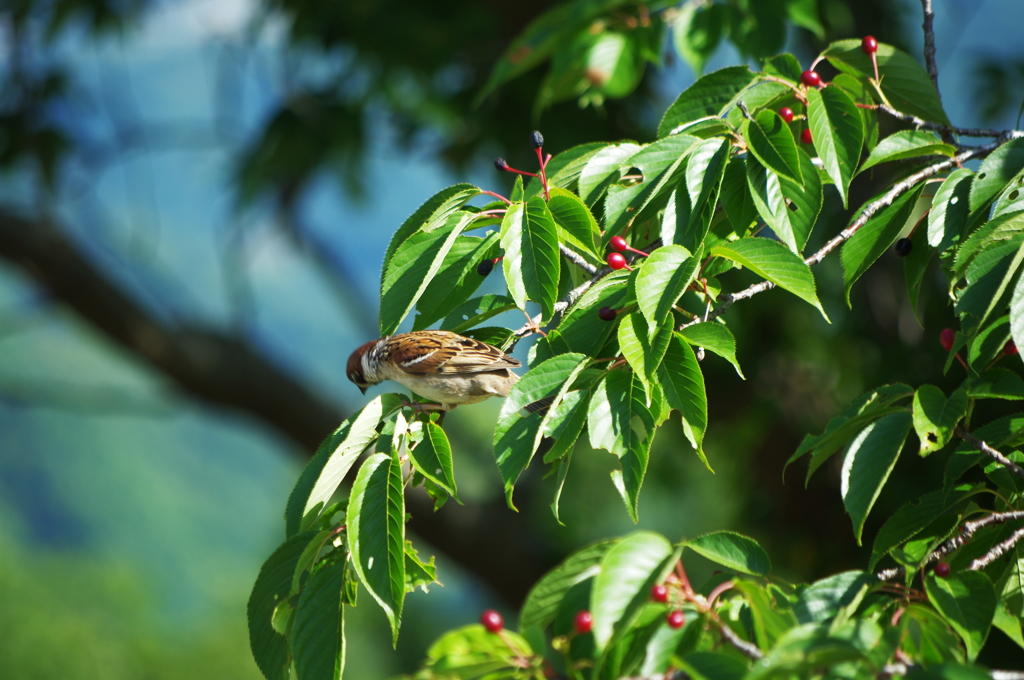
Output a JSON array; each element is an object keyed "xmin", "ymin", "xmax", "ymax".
[{"xmin": 347, "ymin": 331, "xmax": 521, "ymax": 411}]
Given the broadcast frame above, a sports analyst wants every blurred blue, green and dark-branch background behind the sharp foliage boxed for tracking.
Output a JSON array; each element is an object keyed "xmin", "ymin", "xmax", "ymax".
[{"xmin": 0, "ymin": 0, "xmax": 1024, "ymax": 680}]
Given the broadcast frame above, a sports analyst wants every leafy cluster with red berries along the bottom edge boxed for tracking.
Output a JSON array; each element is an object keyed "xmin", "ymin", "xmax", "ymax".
[{"xmin": 403, "ymin": 532, "xmax": 1003, "ymax": 680}]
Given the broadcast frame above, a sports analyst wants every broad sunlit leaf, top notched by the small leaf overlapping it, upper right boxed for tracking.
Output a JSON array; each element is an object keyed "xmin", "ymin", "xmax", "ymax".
[{"xmin": 745, "ymin": 150, "xmax": 822, "ymax": 253}]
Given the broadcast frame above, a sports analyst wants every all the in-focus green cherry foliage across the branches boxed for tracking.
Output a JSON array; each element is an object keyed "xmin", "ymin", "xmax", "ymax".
[{"xmin": 249, "ymin": 17, "xmax": 1024, "ymax": 680}]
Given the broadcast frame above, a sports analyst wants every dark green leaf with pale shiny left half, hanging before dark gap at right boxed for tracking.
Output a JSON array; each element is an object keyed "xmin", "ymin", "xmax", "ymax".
[{"xmin": 841, "ymin": 412, "xmax": 912, "ymax": 545}]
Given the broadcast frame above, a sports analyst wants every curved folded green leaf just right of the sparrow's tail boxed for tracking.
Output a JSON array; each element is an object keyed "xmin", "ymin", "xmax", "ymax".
[{"xmin": 494, "ymin": 353, "xmax": 587, "ymax": 507}]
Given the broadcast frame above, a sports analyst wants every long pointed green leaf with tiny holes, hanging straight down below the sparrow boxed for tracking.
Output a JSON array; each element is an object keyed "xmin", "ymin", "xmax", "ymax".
[{"xmin": 347, "ymin": 454, "xmax": 406, "ymax": 644}]
